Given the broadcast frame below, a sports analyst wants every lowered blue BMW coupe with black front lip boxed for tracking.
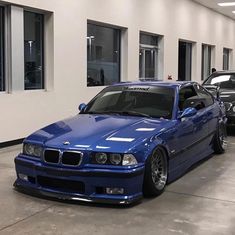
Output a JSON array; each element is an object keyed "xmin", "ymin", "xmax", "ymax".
[{"xmin": 14, "ymin": 81, "xmax": 227, "ymax": 204}]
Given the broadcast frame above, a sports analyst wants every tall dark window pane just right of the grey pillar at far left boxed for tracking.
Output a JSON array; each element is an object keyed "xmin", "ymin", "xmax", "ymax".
[{"xmin": 24, "ymin": 11, "xmax": 44, "ymax": 90}]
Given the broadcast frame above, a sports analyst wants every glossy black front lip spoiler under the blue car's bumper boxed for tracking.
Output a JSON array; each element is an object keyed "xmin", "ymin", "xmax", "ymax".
[{"xmin": 13, "ymin": 180, "xmax": 142, "ymax": 205}]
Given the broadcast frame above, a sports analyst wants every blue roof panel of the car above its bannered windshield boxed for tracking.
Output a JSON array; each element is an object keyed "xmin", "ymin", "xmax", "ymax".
[{"xmin": 112, "ymin": 80, "xmax": 198, "ymax": 89}]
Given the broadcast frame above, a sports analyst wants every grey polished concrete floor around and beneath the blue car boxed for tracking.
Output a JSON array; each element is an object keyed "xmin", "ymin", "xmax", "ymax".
[{"xmin": 0, "ymin": 135, "xmax": 235, "ymax": 235}]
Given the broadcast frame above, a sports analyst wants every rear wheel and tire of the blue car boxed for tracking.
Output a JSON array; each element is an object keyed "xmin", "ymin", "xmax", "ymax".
[{"xmin": 213, "ymin": 124, "xmax": 227, "ymax": 154}]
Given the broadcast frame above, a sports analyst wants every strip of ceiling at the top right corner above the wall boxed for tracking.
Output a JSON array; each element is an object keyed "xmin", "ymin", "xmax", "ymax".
[{"xmin": 194, "ymin": 0, "xmax": 235, "ymax": 20}]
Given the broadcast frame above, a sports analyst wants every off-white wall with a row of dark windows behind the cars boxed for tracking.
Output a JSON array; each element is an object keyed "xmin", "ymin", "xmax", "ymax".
[{"xmin": 0, "ymin": 0, "xmax": 235, "ymax": 143}]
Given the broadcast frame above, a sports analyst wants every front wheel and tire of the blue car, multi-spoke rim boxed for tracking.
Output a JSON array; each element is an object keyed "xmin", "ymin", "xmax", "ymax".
[{"xmin": 143, "ymin": 148, "xmax": 168, "ymax": 197}]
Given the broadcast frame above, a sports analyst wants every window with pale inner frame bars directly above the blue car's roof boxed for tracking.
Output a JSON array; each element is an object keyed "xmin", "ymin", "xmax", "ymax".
[{"xmin": 139, "ymin": 33, "xmax": 159, "ymax": 79}]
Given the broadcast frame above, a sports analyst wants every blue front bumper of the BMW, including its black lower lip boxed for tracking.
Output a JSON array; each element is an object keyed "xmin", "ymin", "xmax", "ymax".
[{"xmin": 14, "ymin": 155, "xmax": 144, "ymax": 204}]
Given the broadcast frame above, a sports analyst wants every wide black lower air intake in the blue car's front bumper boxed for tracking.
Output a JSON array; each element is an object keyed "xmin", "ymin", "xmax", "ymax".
[{"xmin": 37, "ymin": 176, "xmax": 85, "ymax": 193}]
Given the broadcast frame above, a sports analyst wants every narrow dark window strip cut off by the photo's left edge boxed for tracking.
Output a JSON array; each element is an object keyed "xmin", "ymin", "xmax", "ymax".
[{"xmin": 0, "ymin": 7, "xmax": 5, "ymax": 91}]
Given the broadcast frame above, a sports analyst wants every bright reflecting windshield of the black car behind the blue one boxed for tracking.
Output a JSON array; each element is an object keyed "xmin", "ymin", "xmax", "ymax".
[{"xmin": 204, "ymin": 74, "xmax": 235, "ymax": 89}]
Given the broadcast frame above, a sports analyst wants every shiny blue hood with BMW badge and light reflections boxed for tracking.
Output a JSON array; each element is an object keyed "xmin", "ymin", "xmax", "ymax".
[{"xmin": 26, "ymin": 114, "xmax": 172, "ymax": 152}]
